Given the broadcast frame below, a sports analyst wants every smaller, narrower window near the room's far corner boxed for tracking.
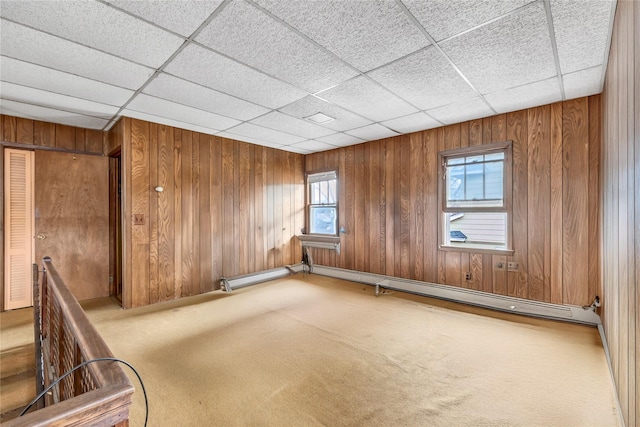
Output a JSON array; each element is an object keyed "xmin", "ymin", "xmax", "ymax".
[{"xmin": 307, "ymin": 171, "xmax": 338, "ymax": 236}]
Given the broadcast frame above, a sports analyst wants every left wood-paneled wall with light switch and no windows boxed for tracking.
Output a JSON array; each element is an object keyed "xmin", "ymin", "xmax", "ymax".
[{"xmin": 107, "ymin": 118, "xmax": 304, "ymax": 307}]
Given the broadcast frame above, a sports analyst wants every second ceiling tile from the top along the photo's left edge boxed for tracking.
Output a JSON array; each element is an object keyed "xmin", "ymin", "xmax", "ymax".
[{"xmin": 0, "ymin": 19, "xmax": 153, "ymax": 89}]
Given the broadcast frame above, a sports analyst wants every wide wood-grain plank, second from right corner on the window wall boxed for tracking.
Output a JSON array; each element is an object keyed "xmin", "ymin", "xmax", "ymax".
[{"xmin": 562, "ymin": 98, "xmax": 592, "ymax": 305}]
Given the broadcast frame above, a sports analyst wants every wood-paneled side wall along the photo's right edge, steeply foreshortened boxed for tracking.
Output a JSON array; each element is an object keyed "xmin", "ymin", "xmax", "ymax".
[{"xmin": 602, "ymin": 1, "xmax": 640, "ymax": 426}]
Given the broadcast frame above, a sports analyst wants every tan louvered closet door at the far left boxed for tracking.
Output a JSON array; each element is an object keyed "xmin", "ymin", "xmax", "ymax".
[{"xmin": 4, "ymin": 149, "xmax": 34, "ymax": 310}]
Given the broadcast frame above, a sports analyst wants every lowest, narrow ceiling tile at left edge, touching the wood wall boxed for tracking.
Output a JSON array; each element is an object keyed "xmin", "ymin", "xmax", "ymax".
[{"xmin": 0, "ymin": 99, "xmax": 109, "ymax": 129}]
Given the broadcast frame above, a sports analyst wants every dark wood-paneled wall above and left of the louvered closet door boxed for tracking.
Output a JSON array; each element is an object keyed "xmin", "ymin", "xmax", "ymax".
[{"xmin": 0, "ymin": 114, "xmax": 104, "ymax": 310}]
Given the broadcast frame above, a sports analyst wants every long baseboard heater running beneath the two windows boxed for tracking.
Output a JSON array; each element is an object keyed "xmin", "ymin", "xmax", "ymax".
[{"xmin": 313, "ymin": 264, "xmax": 602, "ymax": 326}]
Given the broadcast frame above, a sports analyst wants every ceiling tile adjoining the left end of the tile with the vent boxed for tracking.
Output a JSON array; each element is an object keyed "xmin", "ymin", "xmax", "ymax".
[{"xmin": 164, "ymin": 44, "xmax": 307, "ymax": 108}]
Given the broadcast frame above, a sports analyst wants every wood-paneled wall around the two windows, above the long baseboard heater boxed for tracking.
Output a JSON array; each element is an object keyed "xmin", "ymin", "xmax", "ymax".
[{"xmin": 306, "ymin": 96, "xmax": 602, "ymax": 305}]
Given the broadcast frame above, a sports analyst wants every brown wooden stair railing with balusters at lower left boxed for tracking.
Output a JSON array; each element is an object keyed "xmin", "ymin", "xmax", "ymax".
[{"xmin": 3, "ymin": 257, "xmax": 134, "ymax": 426}]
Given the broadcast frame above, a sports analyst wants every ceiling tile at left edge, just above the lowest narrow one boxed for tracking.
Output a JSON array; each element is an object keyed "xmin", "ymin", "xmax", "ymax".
[{"xmin": 0, "ymin": 82, "xmax": 118, "ymax": 119}]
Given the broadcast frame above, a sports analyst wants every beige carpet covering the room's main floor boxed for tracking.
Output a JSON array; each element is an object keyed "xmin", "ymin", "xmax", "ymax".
[{"xmin": 2, "ymin": 274, "xmax": 621, "ymax": 427}]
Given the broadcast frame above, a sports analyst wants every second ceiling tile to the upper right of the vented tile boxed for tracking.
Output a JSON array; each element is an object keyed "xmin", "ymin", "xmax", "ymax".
[{"xmin": 369, "ymin": 48, "xmax": 476, "ymax": 110}]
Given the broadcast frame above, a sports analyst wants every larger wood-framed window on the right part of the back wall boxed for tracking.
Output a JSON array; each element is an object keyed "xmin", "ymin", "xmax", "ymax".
[{"xmin": 438, "ymin": 141, "xmax": 512, "ymax": 253}]
